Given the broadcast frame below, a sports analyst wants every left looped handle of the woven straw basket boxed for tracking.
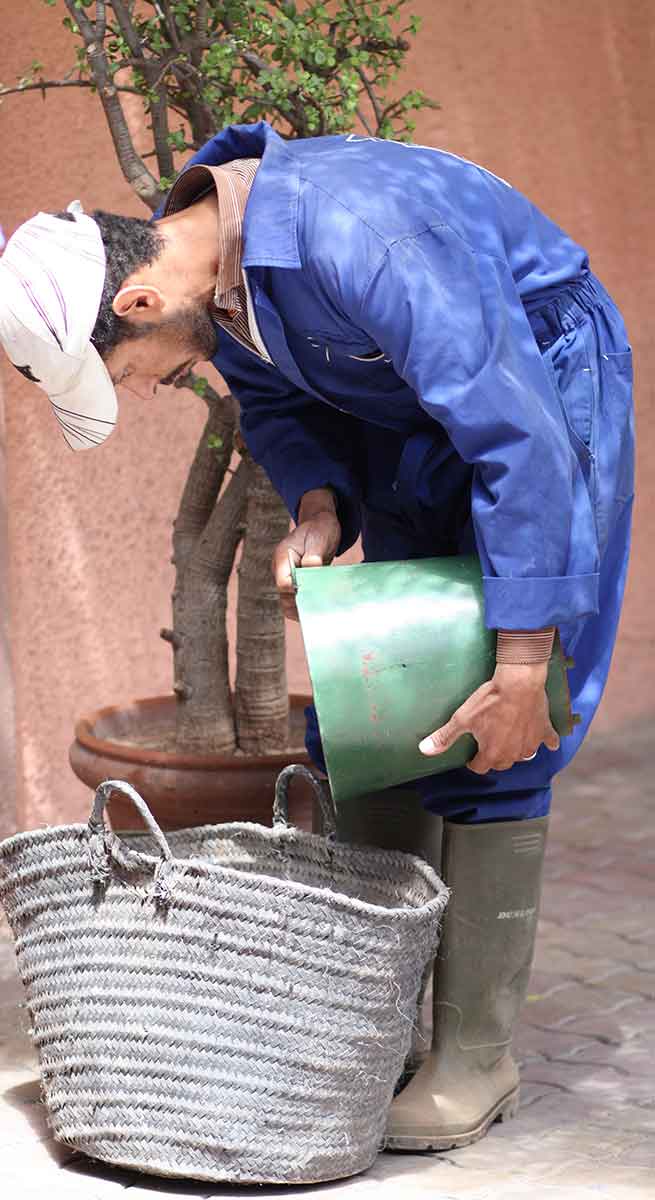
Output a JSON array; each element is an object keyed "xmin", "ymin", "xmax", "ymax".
[{"xmin": 88, "ymin": 779, "xmax": 174, "ymax": 904}]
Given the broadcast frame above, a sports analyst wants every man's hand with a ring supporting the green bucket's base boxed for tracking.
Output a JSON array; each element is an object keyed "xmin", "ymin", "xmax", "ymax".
[{"xmin": 419, "ymin": 662, "xmax": 559, "ymax": 775}]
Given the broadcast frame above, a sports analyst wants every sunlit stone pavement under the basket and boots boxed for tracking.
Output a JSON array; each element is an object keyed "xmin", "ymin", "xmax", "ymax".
[{"xmin": 0, "ymin": 725, "xmax": 655, "ymax": 1200}]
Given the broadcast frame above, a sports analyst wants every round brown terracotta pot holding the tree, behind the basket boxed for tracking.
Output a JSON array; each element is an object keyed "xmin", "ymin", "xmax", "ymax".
[{"xmin": 70, "ymin": 696, "xmax": 313, "ymax": 829}]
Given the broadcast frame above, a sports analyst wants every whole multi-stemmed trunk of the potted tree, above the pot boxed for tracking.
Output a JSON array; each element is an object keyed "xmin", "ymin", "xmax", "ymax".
[{"xmin": 162, "ymin": 388, "xmax": 289, "ymax": 754}]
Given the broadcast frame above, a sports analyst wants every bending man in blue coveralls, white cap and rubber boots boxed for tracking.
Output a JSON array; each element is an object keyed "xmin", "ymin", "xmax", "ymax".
[{"xmin": 0, "ymin": 124, "xmax": 632, "ymax": 1150}]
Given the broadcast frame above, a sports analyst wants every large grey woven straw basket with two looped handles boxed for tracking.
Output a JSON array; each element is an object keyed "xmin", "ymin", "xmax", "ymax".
[{"xmin": 0, "ymin": 767, "xmax": 447, "ymax": 1183}]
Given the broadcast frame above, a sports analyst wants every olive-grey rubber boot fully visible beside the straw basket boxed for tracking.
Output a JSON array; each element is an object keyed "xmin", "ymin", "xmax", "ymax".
[{"xmin": 385, "ymin": 817, "xmax": 548, "ymax": 1151}]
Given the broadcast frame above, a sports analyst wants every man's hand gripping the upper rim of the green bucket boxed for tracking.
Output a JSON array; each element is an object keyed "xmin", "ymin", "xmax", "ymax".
[{"xmin": 272, "ymin": 487, "xmax": 341, "ymax": 620}]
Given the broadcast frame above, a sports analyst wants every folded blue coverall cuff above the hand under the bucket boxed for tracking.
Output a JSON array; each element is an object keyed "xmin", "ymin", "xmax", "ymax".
[{"xmin": 482, "ymin": 575, "xmax": 600, "ymax": 629}]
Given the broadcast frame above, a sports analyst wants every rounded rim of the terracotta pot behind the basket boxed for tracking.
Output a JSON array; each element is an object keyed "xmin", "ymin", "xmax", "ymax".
[{"xmin": 74, "ymin": 692, "xmax": 312, "ymax": 770}]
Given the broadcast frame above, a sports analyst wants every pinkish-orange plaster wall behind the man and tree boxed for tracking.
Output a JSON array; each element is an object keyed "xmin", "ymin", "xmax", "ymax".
[{"xmin": 0, "ymin": 0, "xmax": 655, "ymax": 826}]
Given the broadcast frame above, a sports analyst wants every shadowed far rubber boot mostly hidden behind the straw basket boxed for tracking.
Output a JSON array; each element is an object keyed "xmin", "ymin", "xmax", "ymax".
[{"xmin": 337, "ymin": 787, "xmax": 444, "ymax": 1091}]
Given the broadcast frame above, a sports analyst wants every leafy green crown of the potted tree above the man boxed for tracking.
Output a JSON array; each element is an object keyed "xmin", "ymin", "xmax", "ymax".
[{"xmin": 0, "ymin": 0, "xmax": 437, "ymax": 208}]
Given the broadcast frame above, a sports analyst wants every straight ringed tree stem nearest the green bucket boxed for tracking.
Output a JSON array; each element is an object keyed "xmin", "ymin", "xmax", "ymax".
[{"xmin": 231, "ymin": 464, "xmax": 289, "ymax": 754}]
